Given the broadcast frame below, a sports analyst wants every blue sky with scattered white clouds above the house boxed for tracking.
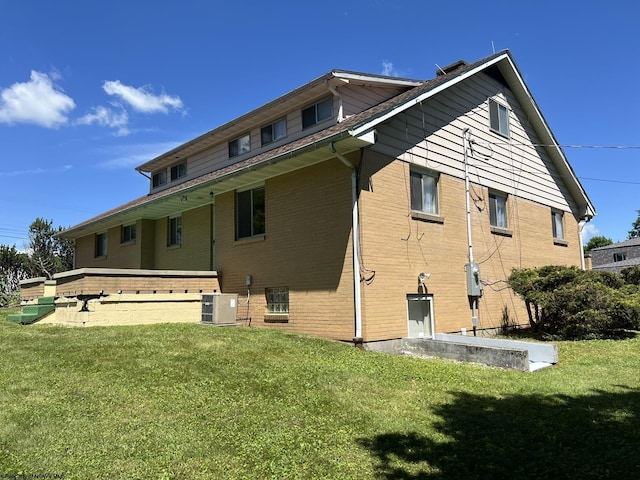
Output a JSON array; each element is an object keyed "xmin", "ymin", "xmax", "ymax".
[{"xmin": 0, "ymin": 0, "xmax": 640, "ymax": 248}]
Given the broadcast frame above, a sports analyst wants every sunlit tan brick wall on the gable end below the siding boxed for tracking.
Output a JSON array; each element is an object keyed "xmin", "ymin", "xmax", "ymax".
[{"xmin": 361, "ymin": 158, "xmax": 580, "ymax": 341}]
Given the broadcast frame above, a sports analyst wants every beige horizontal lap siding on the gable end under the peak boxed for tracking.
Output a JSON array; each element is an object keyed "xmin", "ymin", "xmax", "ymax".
[{"xmin": 372, "ymin": 74, "xmax": 577, "ymax": 218}]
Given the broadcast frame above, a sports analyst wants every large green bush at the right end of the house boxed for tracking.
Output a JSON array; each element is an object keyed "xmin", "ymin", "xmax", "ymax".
[{"xmin": 508, "ymin": 265, "xmax": 640, "ymax": 340}]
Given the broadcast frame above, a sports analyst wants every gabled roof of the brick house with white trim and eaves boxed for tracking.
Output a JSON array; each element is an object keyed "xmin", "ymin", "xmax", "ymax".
[{"xmin": 61, "ymin": 51, "xmax": 595, "ymax": 238}]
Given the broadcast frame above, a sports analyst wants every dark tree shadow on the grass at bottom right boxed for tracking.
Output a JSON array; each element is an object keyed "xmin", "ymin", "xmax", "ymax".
[{"xmin": 359, "ymin": 389, "xmax": 640, "ymax": 480}]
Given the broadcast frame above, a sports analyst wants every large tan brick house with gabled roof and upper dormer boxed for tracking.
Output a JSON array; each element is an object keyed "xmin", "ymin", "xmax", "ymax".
[{"xmin": 47, "ymin": 51, "xmax": 595, "ymax": 342}]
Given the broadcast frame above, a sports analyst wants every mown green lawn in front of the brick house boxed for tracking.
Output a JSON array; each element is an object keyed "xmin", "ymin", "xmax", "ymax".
[{"xmin": 0, "ymin": 313, "xmax": 640, "ymax": 479}]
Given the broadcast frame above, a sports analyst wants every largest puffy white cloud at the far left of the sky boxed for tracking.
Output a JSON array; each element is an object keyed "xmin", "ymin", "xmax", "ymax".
[{"xmin": 0, "ymin": 70, "xmax": 76, "ymax": 128}]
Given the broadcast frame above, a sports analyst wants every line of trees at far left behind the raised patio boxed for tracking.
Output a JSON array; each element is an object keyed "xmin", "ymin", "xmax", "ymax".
[{"xmin": 0, "ymin": 218, "xmax": 74, "ymax": 307}]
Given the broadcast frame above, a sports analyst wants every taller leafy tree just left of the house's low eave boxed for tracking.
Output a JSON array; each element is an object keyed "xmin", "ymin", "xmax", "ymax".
[{"xmin": 29, "ymin": 218, "xmax": 73, "ymax": 280}]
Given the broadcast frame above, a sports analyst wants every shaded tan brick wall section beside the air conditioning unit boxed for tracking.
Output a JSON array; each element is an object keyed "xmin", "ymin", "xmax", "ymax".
[{"xmin": 216, "ymin": 160, "xmax": 354, "ymax": 340}]
